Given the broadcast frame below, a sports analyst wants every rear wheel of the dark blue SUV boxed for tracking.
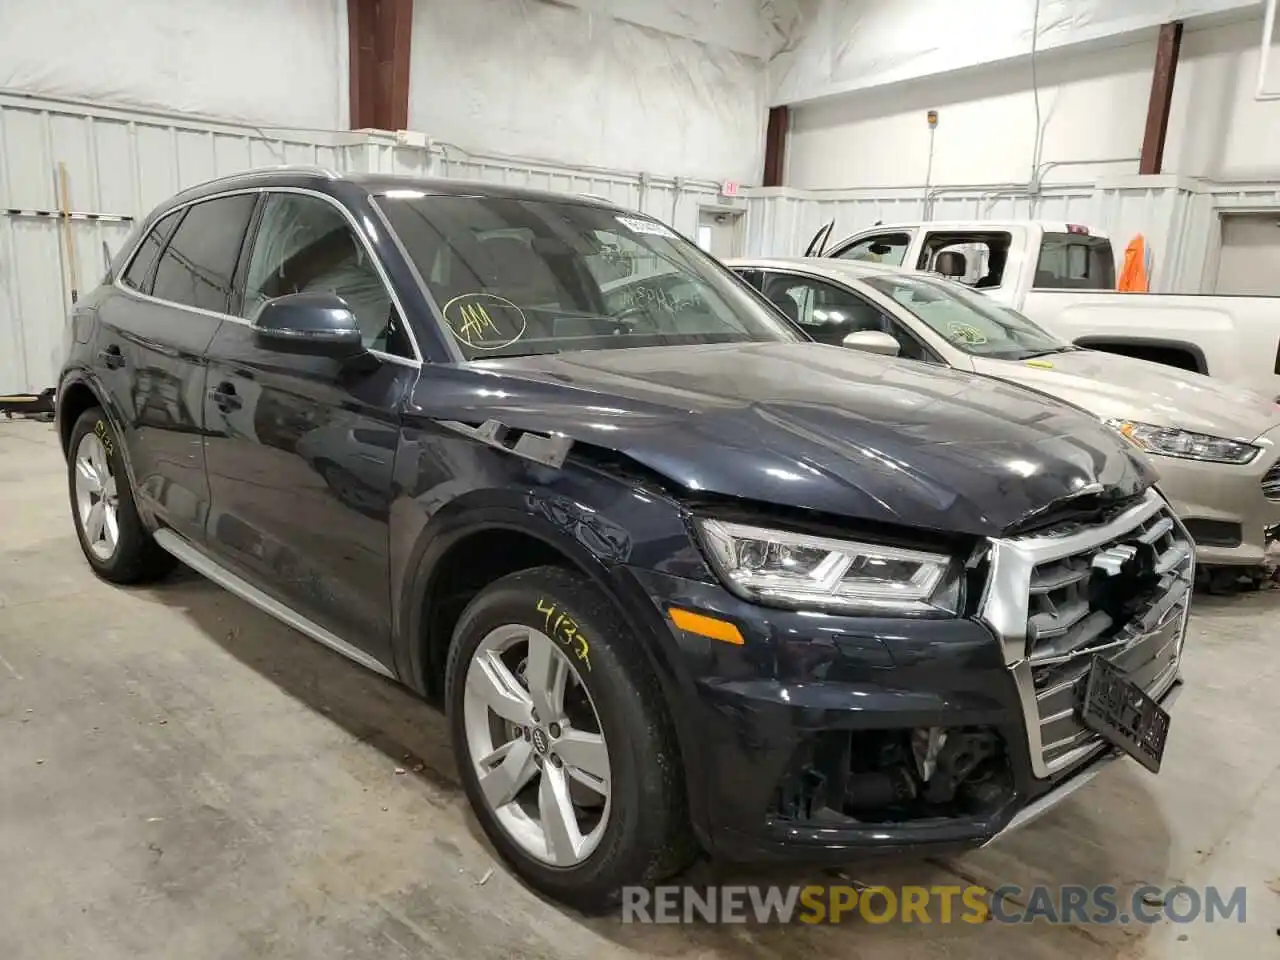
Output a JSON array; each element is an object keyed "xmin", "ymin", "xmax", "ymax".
[{"xmin": 67, "ymin": 407, "xmax": 178, "ymax": 584}]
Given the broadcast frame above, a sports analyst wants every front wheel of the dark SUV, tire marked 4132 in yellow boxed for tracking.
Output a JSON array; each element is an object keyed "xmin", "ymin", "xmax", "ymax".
[{"xmin": 445, "ymin": 567, "xmax": 698, "ymax": 913}]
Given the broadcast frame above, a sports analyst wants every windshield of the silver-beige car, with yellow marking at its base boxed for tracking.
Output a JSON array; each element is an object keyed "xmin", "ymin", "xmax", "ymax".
[{"xmin": 861, "ymin": 275, "xmax": 1076, "ymax": 360}]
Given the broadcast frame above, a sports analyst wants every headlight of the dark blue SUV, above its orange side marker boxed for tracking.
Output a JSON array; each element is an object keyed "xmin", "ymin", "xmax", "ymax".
[{"xmin": 698, "ymin": 520, "xmax": 960, "ymax": 616}]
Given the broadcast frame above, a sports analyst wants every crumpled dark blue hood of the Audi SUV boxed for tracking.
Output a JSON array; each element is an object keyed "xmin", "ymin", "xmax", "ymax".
[{"xmin": 410, "ymin": 343, "xmax": 1155, "ymax": 535}]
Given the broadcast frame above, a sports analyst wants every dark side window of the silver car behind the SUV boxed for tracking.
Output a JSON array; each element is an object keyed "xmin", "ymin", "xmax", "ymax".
[{"xmin": 764, "ymin": 273, "xmax": 933, "ymax": 360}]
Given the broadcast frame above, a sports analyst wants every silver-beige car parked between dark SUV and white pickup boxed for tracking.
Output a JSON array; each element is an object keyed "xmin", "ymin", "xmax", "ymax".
[{"xmin": 727, "ymin": 257, "xmax": 1280, "ymax": 572}]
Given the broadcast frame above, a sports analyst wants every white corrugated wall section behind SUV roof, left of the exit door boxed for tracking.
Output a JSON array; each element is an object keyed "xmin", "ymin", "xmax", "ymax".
[{"xmin": 0, "ymin": 95, "xmax": 748, "ymax": 393}]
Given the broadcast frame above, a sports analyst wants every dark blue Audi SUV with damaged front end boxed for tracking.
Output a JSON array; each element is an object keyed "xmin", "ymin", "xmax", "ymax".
[{"xmin": 58, "ymin": 169, "xmax": 1193, "ymax": 908}]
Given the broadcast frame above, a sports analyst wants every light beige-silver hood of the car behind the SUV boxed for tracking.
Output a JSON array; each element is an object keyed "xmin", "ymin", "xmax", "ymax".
[{"xmin": 974, "ymin": 349, "xmax": 1280, "ymax": 440}]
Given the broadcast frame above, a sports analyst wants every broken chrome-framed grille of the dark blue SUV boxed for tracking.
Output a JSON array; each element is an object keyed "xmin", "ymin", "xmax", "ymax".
[{"xmin": 982, "ymin": 490, "xmax": 1196, "ymax": 777}]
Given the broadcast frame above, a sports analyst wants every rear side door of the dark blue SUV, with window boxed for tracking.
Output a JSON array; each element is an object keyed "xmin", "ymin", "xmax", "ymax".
[{"xmin": 96, "ymin": 193, "xmax": 257, "ymax": 541}]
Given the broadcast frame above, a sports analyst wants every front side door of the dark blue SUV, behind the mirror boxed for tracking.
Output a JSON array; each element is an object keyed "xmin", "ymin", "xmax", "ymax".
[{"xmin": 206, "ymin": 192, "xmax": 419, "ymax": 663}]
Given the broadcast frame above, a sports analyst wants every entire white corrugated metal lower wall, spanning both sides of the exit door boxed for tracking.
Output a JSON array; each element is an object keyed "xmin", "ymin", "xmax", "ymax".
[{"xmin": 0, "ymin": 95, "xmax": 1259, "ymax": 393}]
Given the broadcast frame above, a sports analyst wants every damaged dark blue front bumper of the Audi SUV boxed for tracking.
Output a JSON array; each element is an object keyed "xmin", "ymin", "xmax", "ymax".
[{"xmin": 630, "ymin": 488, "xmax": 1193, "ymax": 863}]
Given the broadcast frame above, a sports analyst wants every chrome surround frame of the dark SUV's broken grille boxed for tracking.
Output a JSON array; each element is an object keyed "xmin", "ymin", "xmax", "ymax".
[{"xmin": 978, "ymin": 488, "xmax": 1196, "ymax": 780}]
